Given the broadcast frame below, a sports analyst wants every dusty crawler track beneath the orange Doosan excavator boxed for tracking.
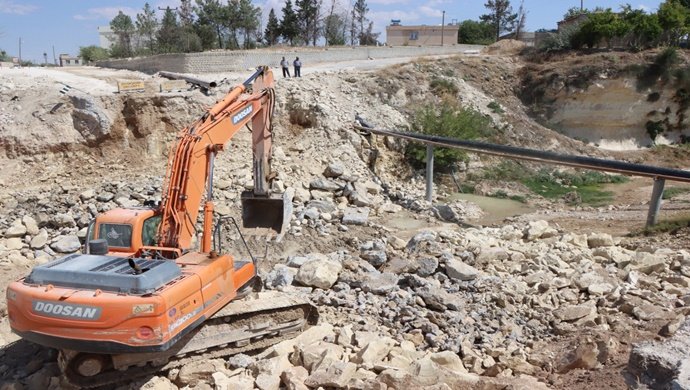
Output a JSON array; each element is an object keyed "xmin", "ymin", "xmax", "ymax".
[{"xmin": 58, "ymin": 292, "xmax": 318, "ymax": 388}]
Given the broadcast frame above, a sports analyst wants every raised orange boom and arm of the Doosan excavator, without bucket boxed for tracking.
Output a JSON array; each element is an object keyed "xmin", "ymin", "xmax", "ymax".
[{"xmin": 158, "ymin": 67, "xmax": 283, "ymax": 253}]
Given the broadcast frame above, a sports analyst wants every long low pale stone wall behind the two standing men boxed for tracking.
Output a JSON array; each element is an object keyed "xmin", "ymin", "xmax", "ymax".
[{"xmin": 96, "ymin": 45, "xmax": 483, "ymax": 73}]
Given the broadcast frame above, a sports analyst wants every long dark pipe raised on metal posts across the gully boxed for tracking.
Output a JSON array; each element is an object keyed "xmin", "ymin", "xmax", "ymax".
[{"xmin": 355, "ymin": 116, "xmax": 690, "ymax": 183}]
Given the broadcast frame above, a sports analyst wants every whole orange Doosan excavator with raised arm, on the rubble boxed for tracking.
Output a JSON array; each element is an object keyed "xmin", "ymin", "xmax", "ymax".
[{"xmin": 7, "ymin": 67, "xmax": 318, "ymax": 388}]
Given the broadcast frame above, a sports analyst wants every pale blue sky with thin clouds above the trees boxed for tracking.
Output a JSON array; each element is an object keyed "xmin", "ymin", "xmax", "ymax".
[{"xmin": 0, "ymin": 0, "xmax": 662, "ymax": 62}]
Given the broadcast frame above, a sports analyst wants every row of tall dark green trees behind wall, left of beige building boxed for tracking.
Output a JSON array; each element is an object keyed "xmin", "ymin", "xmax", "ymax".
[{"xmin": 85, "ymin": 0, "xmax": 379, "ymax": 61}]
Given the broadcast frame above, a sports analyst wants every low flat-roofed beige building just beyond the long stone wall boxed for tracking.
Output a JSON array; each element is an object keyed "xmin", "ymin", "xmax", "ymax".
[{"xmin": 386, "ymin": 21, "xmax": 460, "ymax": 46}]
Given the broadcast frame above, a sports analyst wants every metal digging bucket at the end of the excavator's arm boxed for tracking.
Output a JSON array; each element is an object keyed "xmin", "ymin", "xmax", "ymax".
[{"xmin": 241, "ymin": 191, "xmax": 294, "ymax": 238}]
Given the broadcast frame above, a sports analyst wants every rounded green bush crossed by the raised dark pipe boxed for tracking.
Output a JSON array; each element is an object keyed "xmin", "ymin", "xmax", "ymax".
[{"xmin": 405, "ymin": 99, "xmax": 492, "ymax": 171}]
